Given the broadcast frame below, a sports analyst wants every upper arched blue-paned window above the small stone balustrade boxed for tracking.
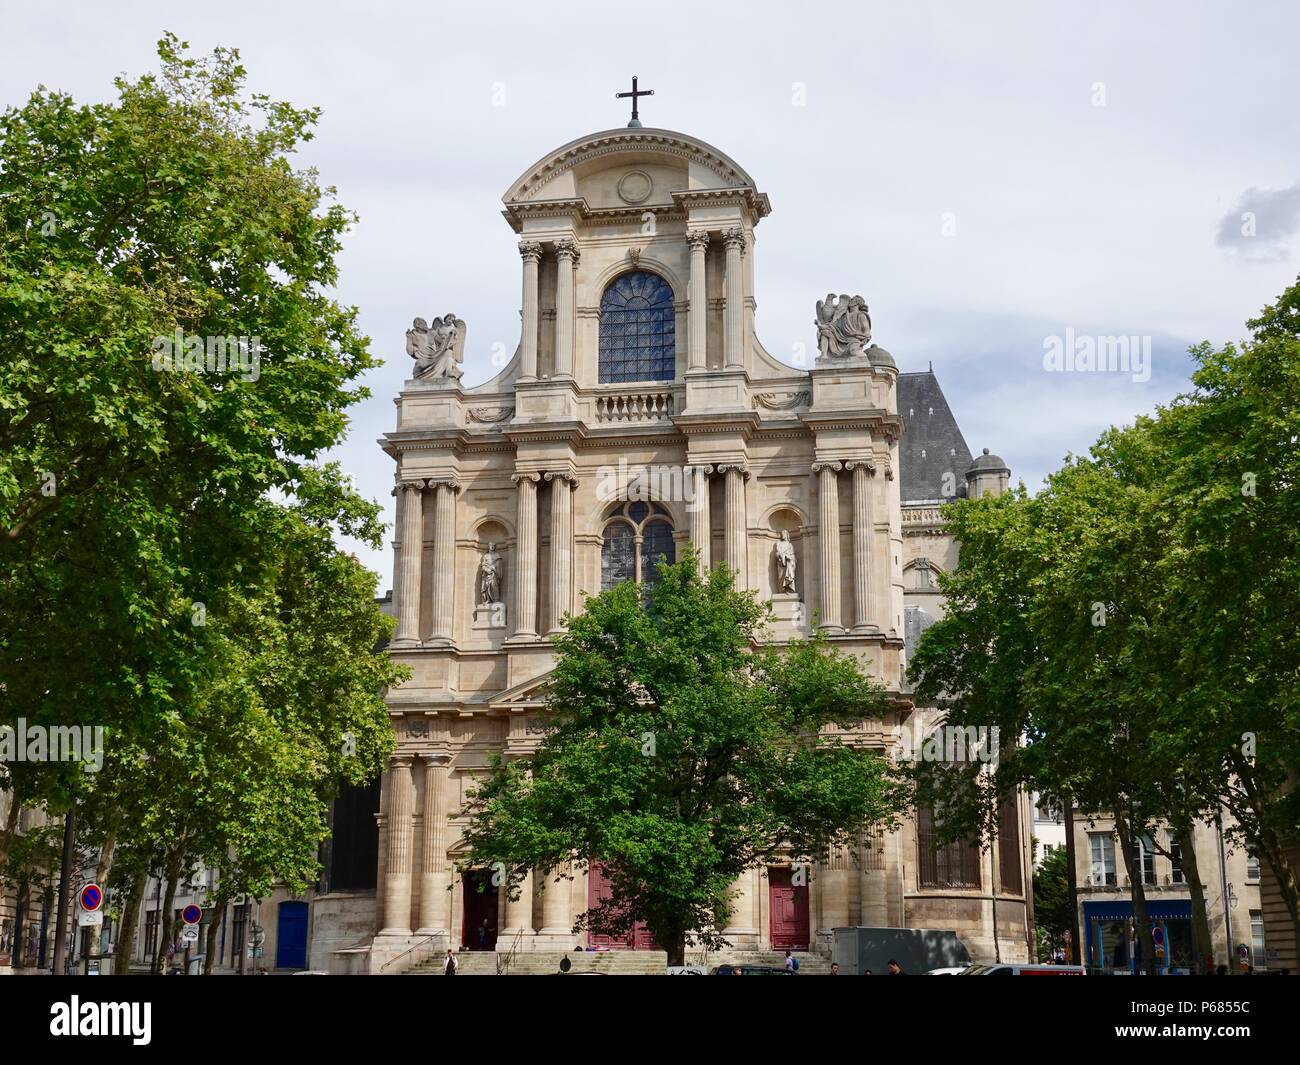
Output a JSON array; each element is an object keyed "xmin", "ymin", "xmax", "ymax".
[{"xmin": 601, "ymin": 270, "xmax": 677, "ymax": 384}]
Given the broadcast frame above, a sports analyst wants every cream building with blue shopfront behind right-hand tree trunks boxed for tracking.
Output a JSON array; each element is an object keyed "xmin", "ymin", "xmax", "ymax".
[{"xmin": 1074, "ymin": 813, "xmax": 1277, "ymax": 973}]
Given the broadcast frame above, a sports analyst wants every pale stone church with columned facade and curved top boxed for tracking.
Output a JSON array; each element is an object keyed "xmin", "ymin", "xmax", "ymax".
[{"xmin": 332, "ymin": 122, "xmax": 1032, "ymax": 971}]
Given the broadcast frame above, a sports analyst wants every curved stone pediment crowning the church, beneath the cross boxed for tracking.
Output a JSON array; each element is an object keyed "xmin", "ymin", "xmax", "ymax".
[{"xmin": 502, "ymin": 129, "xmax": 757, "ymax": 207}]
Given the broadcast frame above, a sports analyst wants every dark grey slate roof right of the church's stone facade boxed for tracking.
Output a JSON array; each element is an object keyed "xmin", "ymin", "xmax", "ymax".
[{"xmin": 898, "ymin": 371, "xmax": 971, "ymax": 503}]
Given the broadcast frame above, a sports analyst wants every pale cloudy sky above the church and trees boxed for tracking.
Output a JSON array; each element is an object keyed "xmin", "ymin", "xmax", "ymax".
[{"xmin": 0, "ymin": 0, "xmax": 1300, "ymax": 590}]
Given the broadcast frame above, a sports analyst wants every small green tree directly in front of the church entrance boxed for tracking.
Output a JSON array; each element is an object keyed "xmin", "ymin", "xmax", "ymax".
[{"xmin": 464, "ymin": 553, "xmax": 897, "ymax": 964}]
